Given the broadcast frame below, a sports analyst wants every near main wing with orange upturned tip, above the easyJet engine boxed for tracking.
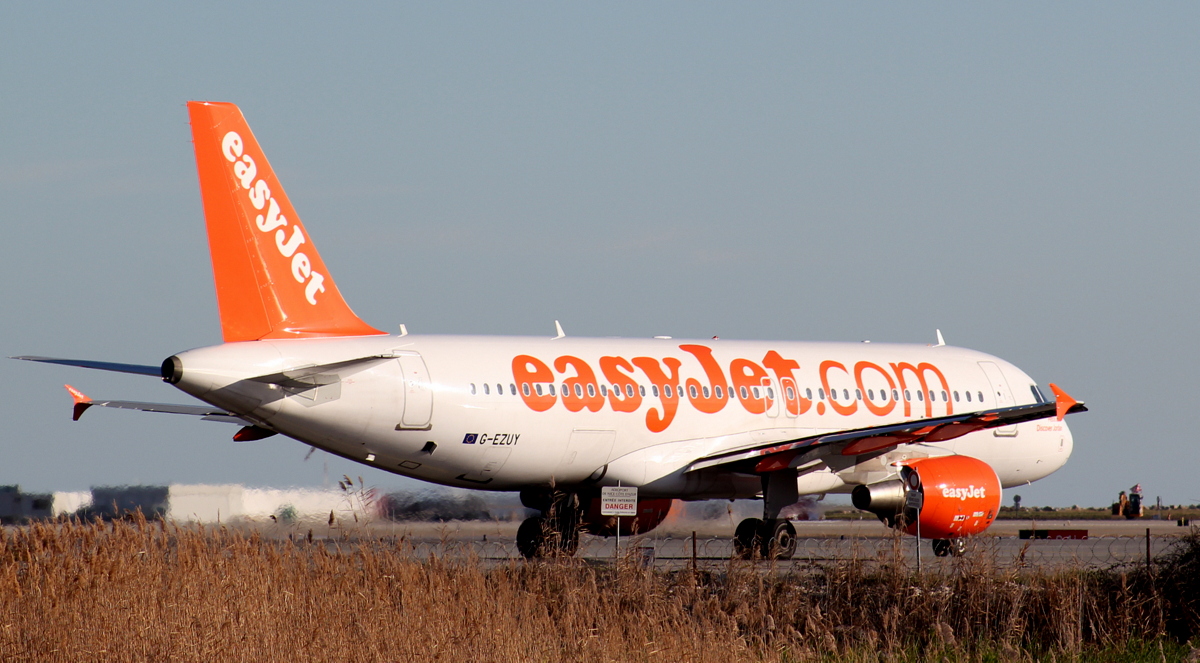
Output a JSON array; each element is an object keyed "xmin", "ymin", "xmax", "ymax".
[{"xmin": 686, "ymin": 384, "xmax": 1087, "ymax": 474}]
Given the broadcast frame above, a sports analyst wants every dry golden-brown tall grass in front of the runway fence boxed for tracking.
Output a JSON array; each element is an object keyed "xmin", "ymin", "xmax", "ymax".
[{"xmin": 0, "ymin": 519, "xmax": 1200, "ymax": 663}]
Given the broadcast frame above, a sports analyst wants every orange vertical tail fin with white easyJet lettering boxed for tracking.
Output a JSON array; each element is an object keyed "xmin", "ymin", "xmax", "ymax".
[{"xmin": 187, "ymin": 101, "xmax": 383, "ymax": 342}]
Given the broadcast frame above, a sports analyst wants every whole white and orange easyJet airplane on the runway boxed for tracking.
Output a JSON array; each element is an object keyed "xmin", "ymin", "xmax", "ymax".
[{"xmin": 17, "ymin": 102, "xmax": 1086, "ymax": 557}]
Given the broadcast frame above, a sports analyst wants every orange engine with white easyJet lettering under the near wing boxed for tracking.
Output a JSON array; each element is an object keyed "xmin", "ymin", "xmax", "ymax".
[{"xmin": 852, "ymin": 455, "xmax": 1001, "ymax": 539}]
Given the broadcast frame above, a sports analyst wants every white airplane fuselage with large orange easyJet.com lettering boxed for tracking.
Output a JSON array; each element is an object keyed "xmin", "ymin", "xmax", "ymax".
[{"xmin": 166, "ymin": 335, "xmax": 1072, "ymax": 498}]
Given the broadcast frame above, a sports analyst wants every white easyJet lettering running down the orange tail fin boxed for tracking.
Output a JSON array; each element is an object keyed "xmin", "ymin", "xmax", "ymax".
[{"xmin": 221, "ymin": 131, "xmax": 325, "ymax": 305}]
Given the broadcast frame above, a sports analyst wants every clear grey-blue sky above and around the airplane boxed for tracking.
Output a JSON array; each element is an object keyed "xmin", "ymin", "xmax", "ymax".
[{"xmin": 0, "ymin": 2, "xmax": 1200, "ymax": 506}]
